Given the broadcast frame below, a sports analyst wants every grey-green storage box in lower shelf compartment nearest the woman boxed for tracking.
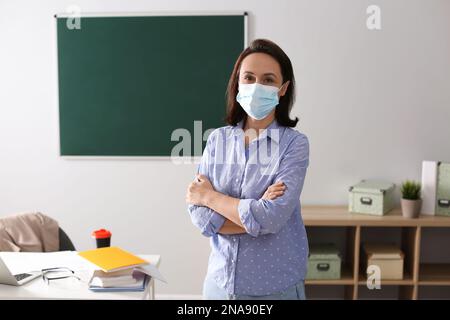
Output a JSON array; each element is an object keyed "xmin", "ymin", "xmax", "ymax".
[{"xmin": 306, "ymin": 244, "xmax": 341, "ymax": 280}]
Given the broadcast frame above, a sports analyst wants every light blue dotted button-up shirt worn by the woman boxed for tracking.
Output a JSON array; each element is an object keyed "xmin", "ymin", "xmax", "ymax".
[{"xmin": 188, "ymin": 120, "xmax": 309, "ymax": 296}]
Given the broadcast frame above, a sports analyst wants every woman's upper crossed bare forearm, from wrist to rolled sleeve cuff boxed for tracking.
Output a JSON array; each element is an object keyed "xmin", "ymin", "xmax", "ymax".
[{"xmin": 205, "ymin": 190, "xmax": 244, "ymax": 228}]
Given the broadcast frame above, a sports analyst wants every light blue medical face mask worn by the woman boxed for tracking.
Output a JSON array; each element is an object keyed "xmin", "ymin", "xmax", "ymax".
[{"xmin": 236, "ymin": 83, "xmax": 281, "ymax": 120}]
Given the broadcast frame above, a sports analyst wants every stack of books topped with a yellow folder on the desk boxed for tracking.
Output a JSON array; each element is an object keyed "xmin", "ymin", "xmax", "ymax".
[{"xmin": 79, "ymin": 247, "xmax": 149, "ymax": 292}]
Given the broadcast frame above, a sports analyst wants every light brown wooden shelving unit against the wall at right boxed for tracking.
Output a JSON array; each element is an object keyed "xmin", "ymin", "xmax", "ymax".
[{"xmin": 302, "ymin": 206, "xmax": 450, "ymax": 300}]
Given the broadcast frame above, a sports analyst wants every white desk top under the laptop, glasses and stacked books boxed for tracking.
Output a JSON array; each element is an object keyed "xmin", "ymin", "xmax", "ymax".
[{"xmin": 0, "ymin": 255, "xmax": 161, "ymax": 300}]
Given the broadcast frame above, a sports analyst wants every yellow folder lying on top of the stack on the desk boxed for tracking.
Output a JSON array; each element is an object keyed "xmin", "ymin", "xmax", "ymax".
[{"xmin": 78, "ymin": 247, "xmax": 148, "ymax": 272}]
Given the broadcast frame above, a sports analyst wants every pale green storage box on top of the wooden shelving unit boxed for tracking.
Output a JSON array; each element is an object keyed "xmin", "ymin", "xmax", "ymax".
[{"xmin": 349, "ymin": 180, "xmax": 395, "ymax": 216}]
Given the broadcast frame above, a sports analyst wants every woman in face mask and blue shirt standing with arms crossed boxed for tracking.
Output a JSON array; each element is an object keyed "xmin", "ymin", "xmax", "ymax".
[{"xmin": 186, "ymin": 39, "xmax": 309, "ymax": 299}]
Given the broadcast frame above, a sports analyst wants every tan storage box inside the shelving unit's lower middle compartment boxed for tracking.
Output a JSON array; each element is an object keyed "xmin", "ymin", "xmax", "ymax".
[{"xmin": 363, "ymin": 244, "xmax": 405, "ymax": 280}]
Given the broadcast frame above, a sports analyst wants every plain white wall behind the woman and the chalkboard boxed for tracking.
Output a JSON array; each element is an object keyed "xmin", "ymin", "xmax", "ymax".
[{"xmin": 0, "ymin": 0, "xmax": 450, "ymax": 294}]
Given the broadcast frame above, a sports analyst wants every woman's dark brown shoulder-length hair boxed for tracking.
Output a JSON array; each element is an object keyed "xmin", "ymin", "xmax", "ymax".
[{"xmin": 225, "ymin": 39, "xmax": 298, "ymax": 127}]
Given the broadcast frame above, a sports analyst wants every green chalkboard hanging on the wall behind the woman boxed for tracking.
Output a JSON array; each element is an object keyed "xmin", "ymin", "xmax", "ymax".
[{"xmin": 56, "ymin": 15, "xmax": 246, "ymax": 156}]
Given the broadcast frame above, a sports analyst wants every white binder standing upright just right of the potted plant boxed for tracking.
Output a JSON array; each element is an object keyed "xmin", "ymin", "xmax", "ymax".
[{"xmin": 421, "ymin": 161, "xmax": 439, "ymax": 215}]
